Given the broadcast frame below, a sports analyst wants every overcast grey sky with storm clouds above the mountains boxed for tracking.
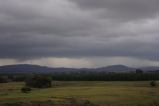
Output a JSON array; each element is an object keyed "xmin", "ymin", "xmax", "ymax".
[{"xmin": 0, "ymin": 0, "xmax": 159, "ymax": 68}]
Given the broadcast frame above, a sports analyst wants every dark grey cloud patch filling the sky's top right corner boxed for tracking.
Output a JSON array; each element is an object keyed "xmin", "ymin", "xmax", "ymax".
[{"xmin": 72, "ymin": 0, "xmax": 159, "ymax": 21}]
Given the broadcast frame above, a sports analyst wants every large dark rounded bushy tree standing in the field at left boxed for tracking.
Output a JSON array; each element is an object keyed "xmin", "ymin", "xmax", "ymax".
[{"xmin": 25, "ymin": 75, "xmax": 52, "ymax": 88}]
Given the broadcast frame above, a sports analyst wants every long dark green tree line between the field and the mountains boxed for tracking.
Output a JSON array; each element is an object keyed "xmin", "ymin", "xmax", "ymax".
[{"xmin": 0, "ymin": 72, "xmax": 159, "ymax": 83}]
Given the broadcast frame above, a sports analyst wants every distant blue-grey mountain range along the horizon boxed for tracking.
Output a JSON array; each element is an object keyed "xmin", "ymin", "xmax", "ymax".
[{"xmin": 0, "ymin": 64, "xmax": 159, "ymax": 73}]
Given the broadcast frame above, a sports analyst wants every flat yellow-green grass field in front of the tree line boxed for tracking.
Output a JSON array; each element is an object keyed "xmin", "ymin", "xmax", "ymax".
[{"xmin": 0, "ymin": 81, "xmax": 159, "ymax": 106}]
